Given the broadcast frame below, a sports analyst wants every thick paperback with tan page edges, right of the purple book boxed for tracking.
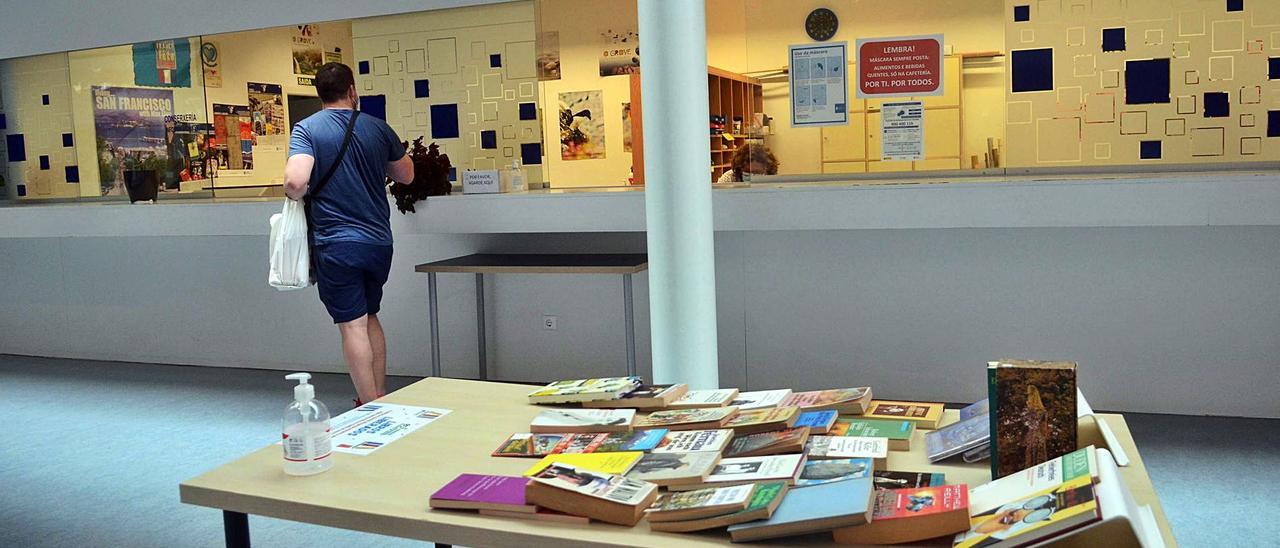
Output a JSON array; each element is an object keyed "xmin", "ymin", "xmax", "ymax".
[{"xmin": 525, "ymin": 463, "xmax": 658, "ymax": 526}]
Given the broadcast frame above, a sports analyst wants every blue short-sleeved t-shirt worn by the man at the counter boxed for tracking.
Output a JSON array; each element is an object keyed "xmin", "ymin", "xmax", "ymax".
[{"xmin": 289, "ymin": 109, "xmax": 404, "ymax": 246}]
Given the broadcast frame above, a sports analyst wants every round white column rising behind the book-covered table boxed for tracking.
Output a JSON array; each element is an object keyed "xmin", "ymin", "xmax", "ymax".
[{"xmin": 639, "ymin": 0, "xmax": 719, "ymax": 388}]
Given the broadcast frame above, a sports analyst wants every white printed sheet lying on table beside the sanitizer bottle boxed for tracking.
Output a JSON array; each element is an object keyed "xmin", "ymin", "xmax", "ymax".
[{"xmin": 329, "ymin": 403, "xmax": 452, "ymax": 456}]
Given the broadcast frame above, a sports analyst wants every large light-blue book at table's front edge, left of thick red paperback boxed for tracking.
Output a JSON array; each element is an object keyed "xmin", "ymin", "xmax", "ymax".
[{"xmin": 728, "ymin": 468, "xmax": 874, "ymax": 543}]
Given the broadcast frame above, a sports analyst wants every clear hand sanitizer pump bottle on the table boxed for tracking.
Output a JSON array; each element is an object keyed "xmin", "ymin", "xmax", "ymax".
[{"xmin": 283, "ymin": 373, "xmax": 333, "ymax": 476}]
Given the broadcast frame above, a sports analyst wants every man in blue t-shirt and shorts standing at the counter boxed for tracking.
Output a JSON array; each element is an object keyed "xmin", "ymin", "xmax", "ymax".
[{"xmin": 284, "ymin": 63, "xmax": 413, "ymax": 405}]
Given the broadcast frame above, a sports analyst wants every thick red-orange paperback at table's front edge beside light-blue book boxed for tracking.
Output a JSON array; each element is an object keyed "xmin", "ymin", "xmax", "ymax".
[{"xmin": 832, "ymin": 484, "xmax": 969, "ymax": 544}]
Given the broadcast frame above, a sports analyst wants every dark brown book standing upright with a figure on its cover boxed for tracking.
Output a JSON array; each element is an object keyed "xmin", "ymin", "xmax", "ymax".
[{"xmin": 987, "ymin": 360, "xmax": 1076, "ymax": 479}]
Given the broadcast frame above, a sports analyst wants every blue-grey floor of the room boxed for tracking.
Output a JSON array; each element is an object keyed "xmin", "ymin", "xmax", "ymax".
[{"xmin": 0, "ymin": 355, "xmax": 1280, "ymax": 547}]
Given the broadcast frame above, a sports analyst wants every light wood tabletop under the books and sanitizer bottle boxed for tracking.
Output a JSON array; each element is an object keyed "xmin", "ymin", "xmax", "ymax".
[{"xmin": 179, "ymin": 378, "xmax": 1175, "ymax": 548}]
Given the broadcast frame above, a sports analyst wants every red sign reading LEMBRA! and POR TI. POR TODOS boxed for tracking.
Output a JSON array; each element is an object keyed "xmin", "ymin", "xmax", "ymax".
[{"xmin": 858, "ymin": 35, "xmax": 942, "ymax": 99}]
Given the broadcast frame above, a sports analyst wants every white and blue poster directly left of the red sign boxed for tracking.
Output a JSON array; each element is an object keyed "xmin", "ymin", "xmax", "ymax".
[{"xmin": 791, "ymin": 42, "xmax": 849, "ymax": 127}]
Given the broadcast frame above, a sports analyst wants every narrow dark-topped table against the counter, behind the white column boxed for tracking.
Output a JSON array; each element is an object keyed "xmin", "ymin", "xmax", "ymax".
[{"xmin": 413, "ymin": 254, "xmax": 649, "ymax": 380}]
